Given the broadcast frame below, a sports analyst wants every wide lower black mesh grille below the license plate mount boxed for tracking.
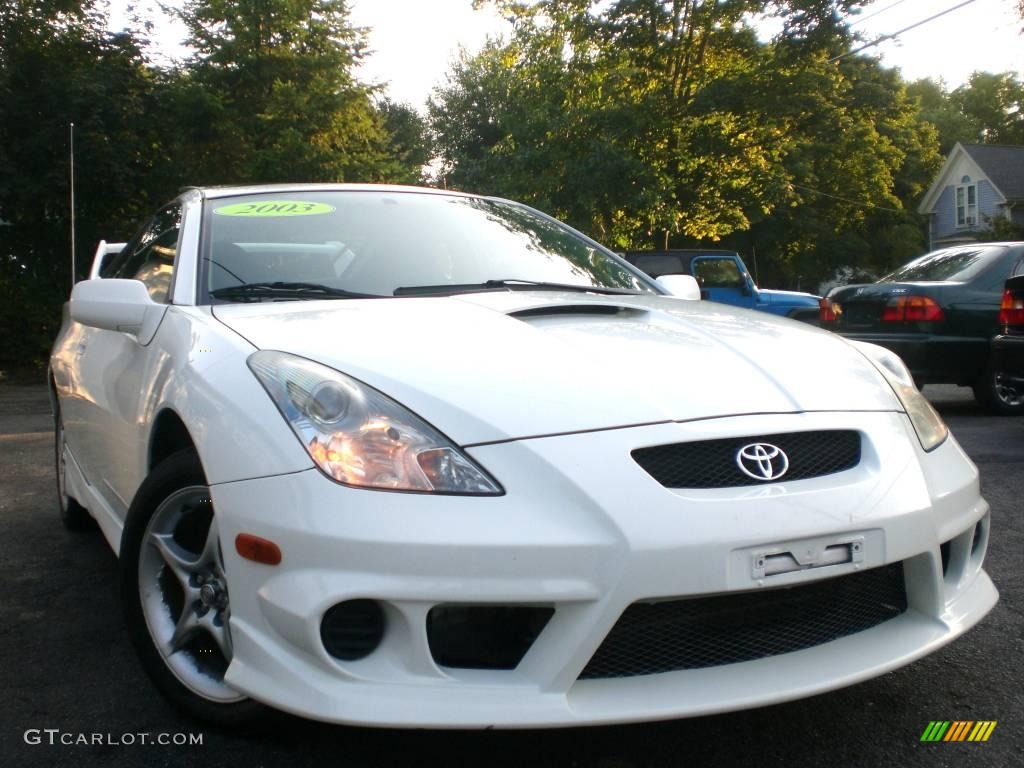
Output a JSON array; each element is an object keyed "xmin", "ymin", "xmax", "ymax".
[{"xmin": 580, "ymin": 563, "xmax": 906, "ymax": 680}]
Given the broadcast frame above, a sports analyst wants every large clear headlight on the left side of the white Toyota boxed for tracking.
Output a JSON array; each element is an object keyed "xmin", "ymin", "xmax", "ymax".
[{"xmin": 248, "ymin": 351, "xmax": 504, "ymax": 496}]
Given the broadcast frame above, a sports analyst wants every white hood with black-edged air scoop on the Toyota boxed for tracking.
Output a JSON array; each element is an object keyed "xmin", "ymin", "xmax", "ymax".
[{"xmin": 213, "ymin": 291, "xmax": 900, "ymax": 445}]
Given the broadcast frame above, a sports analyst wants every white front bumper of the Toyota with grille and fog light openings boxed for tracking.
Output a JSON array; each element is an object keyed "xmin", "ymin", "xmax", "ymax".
[{"xmin": 211, "ymin": 413, "xmax": 997, "ymax": 727}]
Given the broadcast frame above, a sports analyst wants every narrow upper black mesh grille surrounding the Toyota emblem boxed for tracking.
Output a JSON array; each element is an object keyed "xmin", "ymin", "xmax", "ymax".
[{"xmin": 633, "ymin": 429, "xmax": 860, "ymax": 488}]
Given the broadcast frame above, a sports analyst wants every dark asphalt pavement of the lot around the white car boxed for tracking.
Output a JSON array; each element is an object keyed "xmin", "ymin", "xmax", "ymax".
[{"xmin": 0, "ymin": 385, "xmax": 1024, "ymax": 768}]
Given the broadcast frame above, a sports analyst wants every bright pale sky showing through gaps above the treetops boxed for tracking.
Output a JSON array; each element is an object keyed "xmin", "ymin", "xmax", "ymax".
[{"xmin": 110, "ymin": 0, "xmax": 1024, "ymax": 108}]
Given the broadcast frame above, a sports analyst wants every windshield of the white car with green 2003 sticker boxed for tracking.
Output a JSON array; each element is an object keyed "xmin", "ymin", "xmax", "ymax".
[{"xmin": 195, "ymin": 190, "xmax": 657, "ymax": 302}]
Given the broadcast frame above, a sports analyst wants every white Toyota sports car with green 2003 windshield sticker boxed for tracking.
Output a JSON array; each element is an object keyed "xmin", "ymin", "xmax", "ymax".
[{"xmin": 50, "ymin": 185, "xmax": 997, "ymax": 727}]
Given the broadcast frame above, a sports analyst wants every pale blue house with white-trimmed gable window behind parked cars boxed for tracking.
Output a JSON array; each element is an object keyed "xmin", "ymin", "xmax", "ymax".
[{"xmin": 918, "ymin": 141, "xmax": 1024, "ymax": 250}]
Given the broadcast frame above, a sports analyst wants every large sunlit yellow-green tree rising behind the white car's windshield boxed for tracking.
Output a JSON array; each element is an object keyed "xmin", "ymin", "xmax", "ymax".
[{"xmin": 430, "ymin": 0, "xmax": 849, "ymax": 245}]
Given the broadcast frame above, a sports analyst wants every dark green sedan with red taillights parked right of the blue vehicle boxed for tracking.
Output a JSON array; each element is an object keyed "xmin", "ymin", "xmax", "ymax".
[{"xmin": 820, "ymin": 243, "xmax": 1024, "ymax": 415}]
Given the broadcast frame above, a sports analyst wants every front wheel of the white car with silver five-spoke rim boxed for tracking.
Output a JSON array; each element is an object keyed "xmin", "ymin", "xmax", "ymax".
[{"xmin": 120, "ymin": 449, "xmax": 264, "ymax": 725}]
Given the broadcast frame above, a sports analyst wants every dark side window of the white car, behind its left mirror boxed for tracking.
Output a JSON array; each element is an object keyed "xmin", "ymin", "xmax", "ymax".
[{"xmin": 100, "ymin": 205, "xmax": 181, "ymax": 302}]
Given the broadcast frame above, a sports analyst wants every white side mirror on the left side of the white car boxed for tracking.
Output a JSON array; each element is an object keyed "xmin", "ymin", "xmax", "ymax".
[{"xmin": 71, "ymin": 280, "xmax": 167, "ymax": 344}]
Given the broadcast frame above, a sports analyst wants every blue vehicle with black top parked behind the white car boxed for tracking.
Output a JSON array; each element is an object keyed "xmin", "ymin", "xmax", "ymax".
[{"xmin": 623, "ymin": 249, "xmax": 820, "ymax": 323}]
